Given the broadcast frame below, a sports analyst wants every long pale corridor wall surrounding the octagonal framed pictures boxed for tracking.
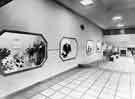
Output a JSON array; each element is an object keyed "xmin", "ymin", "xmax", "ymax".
[{"xmin": 0, "ymin": 0, "xmax": 102, "ymax": 97}]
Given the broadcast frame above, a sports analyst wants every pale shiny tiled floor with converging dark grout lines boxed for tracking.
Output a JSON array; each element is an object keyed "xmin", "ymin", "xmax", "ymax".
[{"xmin": 6, "ymin": 57, "xmax": 135, "ymax": 99}]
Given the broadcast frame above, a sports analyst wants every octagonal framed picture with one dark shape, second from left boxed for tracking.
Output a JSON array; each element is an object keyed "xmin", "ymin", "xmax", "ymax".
[{"xmin": 59, "ymin": 37, "xmax": 78, "ymax": 61}]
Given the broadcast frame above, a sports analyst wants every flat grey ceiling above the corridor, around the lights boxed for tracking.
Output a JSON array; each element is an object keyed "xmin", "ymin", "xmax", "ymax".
[{"xmin": 56, "ymin": 0, "xmax": 135, "ymax": 29}]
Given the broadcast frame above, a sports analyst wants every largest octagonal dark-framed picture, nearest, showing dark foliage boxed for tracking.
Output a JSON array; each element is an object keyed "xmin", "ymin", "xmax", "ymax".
[{"xmin": 0, "ymin": 30, "xmax": 47, "ymax": 75}]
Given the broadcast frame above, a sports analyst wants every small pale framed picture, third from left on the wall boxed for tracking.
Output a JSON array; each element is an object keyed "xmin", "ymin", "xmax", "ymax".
[{"xmin": 86, "ymin": 40, "xmax": 94, "ymax": 56}]
